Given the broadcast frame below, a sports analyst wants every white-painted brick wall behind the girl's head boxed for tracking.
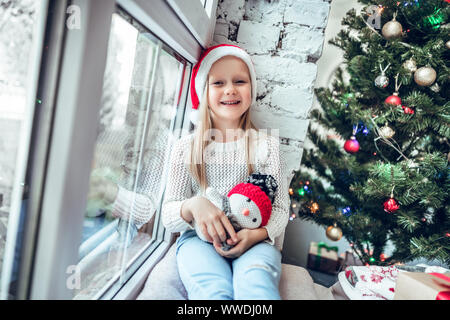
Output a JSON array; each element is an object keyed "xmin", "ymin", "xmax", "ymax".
[{"xmin": 212, "ymin": 0, "xmax": 330, "ymax": 181}]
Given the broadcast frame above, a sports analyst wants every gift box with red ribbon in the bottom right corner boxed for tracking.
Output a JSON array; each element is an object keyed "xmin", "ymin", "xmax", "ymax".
[{"xmin": 394, "ymin": 272, "xmax": 450, "ymax": 300}]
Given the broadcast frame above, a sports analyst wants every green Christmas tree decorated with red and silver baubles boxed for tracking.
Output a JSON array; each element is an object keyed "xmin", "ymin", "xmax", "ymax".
[{"xmin": 289, "ymin": 0, "xmax": 450, "ymax": 265}]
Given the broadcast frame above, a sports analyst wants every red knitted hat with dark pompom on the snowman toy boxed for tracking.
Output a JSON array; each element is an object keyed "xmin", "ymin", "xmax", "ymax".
[{"xmin": 227, "ymin": 173, "xmax": 278, "ymax": 227}]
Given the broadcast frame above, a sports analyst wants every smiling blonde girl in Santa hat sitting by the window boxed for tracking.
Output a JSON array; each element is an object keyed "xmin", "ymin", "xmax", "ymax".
[{"xmin": 162, "ymin": 44, "xmax": 289, "ymax": 300}]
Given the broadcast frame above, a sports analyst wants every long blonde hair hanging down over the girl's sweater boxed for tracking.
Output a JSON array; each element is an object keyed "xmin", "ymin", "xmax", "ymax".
[{"xmin": 189, "ymin": 76, "xmax": 258, "ymax": 191}]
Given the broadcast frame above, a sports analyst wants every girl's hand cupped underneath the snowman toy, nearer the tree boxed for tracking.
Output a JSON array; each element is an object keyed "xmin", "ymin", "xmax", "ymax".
[{"xmin": 214, "ymin": 228, "xmax": 268, "ymax": 258}]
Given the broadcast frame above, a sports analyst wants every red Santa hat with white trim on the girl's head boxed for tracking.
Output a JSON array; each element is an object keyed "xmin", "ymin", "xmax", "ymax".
[{"xmin": 190, "ymin": 44, "xmax": 256, "ymax": 123}]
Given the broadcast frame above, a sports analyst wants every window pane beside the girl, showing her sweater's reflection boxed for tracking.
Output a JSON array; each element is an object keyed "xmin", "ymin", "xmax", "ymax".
[{"xmin": 75, "ymin": 13, "xmax": 186, "ymax": 299}]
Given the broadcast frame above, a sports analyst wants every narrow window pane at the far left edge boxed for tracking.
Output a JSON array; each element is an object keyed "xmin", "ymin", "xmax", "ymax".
[{"xmin": 0, "ymin": 0, "xmax": 41, "ymax": 298}]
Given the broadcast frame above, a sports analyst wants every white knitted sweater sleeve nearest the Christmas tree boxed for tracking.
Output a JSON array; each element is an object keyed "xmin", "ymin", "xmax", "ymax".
[{"xmin": 263, "ymin": 136, "xmax": 289, "ymax": 245}]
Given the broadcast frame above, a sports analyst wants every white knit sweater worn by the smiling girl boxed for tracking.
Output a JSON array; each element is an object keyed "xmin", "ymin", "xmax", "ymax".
[{"xmin": 162, "ymin": 129, "xmax": 289, "ymax": 250}]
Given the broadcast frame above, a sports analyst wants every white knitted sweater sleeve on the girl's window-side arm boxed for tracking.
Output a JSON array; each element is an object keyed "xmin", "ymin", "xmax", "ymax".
[{"xmin": 161, "ymin": 136, "xmax": 193, "ymax": 232}]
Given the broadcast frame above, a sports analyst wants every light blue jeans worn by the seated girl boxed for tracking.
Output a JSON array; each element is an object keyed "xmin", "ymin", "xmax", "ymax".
[{"xmin": 176, "ymin": 230, "xmax": 281, "ymax": 300}]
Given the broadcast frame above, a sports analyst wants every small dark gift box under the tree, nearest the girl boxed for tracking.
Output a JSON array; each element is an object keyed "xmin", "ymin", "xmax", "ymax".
[{"xmin": 308, "ymin": 242, "xmax": 339, "ymax": 274}]
